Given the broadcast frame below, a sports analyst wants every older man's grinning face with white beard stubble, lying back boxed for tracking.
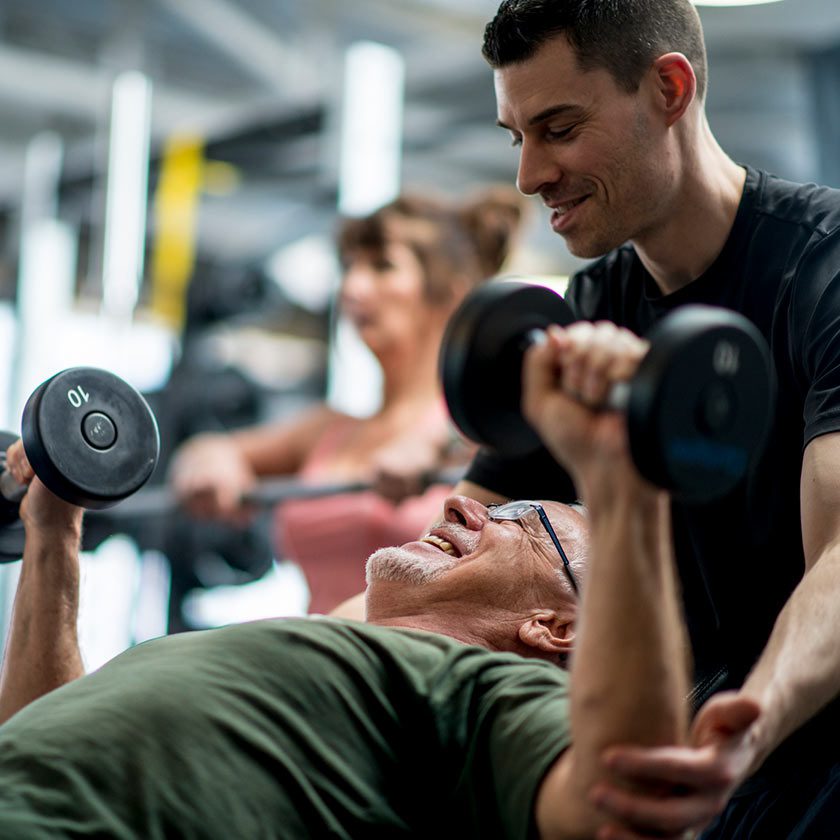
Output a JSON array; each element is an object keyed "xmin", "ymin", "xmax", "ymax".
[{"xmin": 367, "ymin": 496, "xmax": 586, "ymax": 620}]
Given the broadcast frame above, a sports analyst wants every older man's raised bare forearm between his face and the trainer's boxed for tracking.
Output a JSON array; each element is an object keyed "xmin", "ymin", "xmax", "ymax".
[{"xmin": 572, "ymin": 476, "xmax": 689, "ymax": 782}]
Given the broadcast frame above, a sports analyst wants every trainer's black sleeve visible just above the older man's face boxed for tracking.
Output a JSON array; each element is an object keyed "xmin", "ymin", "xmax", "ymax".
[{"xmin": 465, "ymin": 447, "xmax": 578, "ymax": 503}]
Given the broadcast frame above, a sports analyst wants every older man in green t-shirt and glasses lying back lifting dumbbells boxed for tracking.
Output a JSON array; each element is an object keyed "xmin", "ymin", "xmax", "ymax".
[{"xmin": 0, "ymin": 324, "xmax": 708, "ymax": 840}]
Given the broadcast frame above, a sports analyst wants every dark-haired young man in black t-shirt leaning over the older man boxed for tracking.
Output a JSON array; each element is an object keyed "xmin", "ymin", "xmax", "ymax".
[{"xmin": 457, "ymin": 0, "xmax": 840, "ymax": 838}]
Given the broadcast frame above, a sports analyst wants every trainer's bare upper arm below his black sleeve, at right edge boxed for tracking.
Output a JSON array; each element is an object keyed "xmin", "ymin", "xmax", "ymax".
[{"xmin": 800, "ymin": 432, "xmax": 840, "ymax": 569}]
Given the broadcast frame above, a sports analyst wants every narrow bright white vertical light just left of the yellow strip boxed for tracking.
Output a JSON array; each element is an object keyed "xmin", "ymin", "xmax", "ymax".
[{"xmin": 102, "ymin": 71, "xmax": 152, "ymax": 318}]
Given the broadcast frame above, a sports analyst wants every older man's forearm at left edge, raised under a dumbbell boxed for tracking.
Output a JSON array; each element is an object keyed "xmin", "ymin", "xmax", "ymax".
[{"xmin": 0, "ymin": 444, "xmax": 84, "ymax": 723}]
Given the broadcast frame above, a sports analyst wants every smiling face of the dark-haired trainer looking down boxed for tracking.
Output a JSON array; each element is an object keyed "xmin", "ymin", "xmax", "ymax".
[{"xmin": 494, "ymin": 36, "xmax": 672, "ymax": 258}]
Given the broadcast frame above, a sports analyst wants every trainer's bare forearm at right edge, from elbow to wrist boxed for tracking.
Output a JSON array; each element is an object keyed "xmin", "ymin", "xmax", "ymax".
[{"xmin": 743, "ymin": 545, "xmax": 840, "ymax": 770}]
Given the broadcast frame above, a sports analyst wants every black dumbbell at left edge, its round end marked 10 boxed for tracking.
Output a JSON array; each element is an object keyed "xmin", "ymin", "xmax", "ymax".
[{"xmin": 0, "ymin": 367, "xmax": 160, "ymax": 562}]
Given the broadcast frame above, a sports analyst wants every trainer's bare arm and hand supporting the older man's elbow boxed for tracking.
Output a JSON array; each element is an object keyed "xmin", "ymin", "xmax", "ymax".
[{"xmin": 588, "ymin": 416, "xmax": 840, "ymax": 831}]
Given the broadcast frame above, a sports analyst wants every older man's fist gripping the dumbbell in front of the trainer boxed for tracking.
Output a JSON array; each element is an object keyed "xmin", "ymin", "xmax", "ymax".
[{"xmin": 522, "ymin": 321, "xmax": 648, "ymax": 474}]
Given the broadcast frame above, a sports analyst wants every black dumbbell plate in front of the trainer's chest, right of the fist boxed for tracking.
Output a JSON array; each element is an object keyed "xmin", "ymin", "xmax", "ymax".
[{"xmin": 627, "ymin": 306, "xmax": 774, "ymax": 502}]
